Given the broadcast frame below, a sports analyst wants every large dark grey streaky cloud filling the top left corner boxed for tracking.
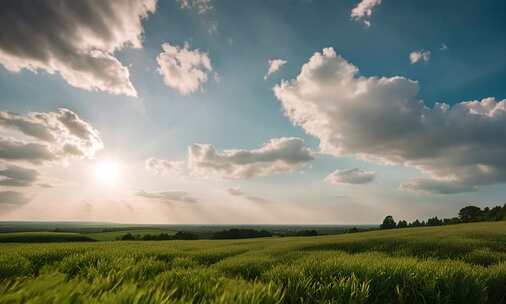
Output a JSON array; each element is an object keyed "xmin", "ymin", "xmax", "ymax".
[{"xmin": 0, "ymin": 0, "xmax": 156, "ymax": 96}]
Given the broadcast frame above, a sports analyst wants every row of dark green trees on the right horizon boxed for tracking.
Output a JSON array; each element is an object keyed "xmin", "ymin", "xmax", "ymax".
[{"xmin": 380, "ymin": 204, "xmax": 506, "ymax": 229}]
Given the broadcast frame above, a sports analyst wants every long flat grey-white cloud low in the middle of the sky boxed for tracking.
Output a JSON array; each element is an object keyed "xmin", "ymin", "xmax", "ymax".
[{"xmin": 146, "ymin": 137, "xmax": 314, "ymax": 179}]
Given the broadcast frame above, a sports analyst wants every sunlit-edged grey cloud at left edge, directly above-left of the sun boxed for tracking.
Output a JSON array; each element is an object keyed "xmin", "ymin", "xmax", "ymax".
[{"xmin": 0, "ymin": 108, "xmax": 103, "ymax": 163}]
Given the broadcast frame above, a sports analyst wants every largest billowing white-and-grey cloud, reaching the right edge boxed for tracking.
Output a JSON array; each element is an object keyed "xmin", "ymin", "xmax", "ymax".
[{"xmin": 274, "ymin": 48, "xmax": 506, "ymax": 193}]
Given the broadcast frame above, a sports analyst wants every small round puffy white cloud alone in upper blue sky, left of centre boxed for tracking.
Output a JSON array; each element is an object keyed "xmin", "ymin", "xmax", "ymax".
[{"xmin": 156, "ymin": 42, "xmax": 213, "ymax": 95}]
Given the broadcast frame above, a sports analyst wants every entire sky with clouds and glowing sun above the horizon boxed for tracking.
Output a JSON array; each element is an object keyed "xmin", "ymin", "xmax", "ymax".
[{"xmin": 0, "ymin": 0, "xmax": 506, "ymax": 224}]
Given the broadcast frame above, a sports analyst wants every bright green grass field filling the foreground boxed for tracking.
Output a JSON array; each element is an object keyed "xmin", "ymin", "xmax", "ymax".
[{"xmin": 0, "ymin": 222, "xmax": 506, "ymax": 303}]
